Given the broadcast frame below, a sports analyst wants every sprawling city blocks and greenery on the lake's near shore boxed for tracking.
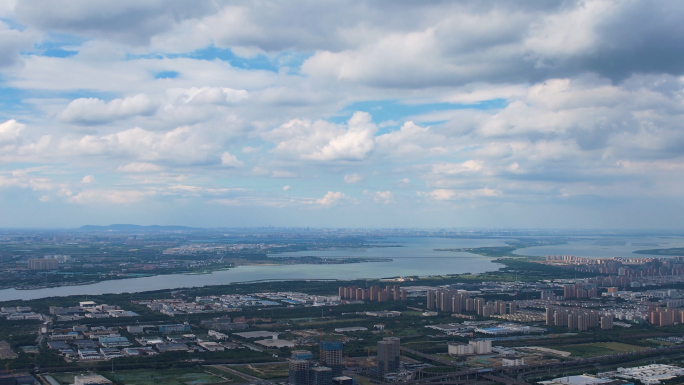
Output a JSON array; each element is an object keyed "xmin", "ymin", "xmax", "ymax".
[{"xmin": 0, "ymin": 231, "xmax": 684, "ymax": 385}]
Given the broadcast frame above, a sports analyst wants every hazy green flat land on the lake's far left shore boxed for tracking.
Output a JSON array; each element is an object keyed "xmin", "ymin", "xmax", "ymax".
[{"xmin": 0, "ymin": 231, "xmax": 384, "ymax": 289}]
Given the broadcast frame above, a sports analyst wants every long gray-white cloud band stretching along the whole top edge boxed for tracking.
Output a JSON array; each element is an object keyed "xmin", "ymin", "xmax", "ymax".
[{"xmin": 16, "ymin": 0, "xmax": 684, "ymax": 88}]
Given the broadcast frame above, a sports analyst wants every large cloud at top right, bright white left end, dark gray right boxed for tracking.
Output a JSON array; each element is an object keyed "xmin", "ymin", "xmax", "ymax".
[{"xmin": 296, "ymin": 2, "xmax": 684, "ymax": 88}]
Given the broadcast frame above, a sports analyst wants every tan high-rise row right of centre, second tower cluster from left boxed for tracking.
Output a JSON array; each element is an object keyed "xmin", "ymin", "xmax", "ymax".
[{"xmin": 426, "ymin": 289, "xmax": 518, "ymax": 317}]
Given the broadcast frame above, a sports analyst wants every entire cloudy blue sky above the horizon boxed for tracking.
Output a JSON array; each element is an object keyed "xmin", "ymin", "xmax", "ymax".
[{"xmin": 0, "ymin": 0, "xmax": 684, "ymax": 229}]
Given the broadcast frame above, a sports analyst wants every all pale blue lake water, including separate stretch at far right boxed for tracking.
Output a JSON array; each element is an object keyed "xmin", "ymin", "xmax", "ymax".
[{"xmin": 6, "ymin": 232, "xmax": 684, "ymax": 301}]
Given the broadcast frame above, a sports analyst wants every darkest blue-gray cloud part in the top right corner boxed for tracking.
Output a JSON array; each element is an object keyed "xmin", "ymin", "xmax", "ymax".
[{"xmin": 526, "ymin": 1, "xmax": 684, "ymax": 82}]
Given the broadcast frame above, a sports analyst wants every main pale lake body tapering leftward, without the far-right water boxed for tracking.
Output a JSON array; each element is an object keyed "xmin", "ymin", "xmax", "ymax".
[{"xmin": 0, "ymin": 237, "xmax": 505, "ymax": 301}]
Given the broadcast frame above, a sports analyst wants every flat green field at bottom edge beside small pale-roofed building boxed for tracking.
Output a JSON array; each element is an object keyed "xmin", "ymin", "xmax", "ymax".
[{"xmin": 104, "ymin": 368, "xmax": 226, "ymax": 385}]
